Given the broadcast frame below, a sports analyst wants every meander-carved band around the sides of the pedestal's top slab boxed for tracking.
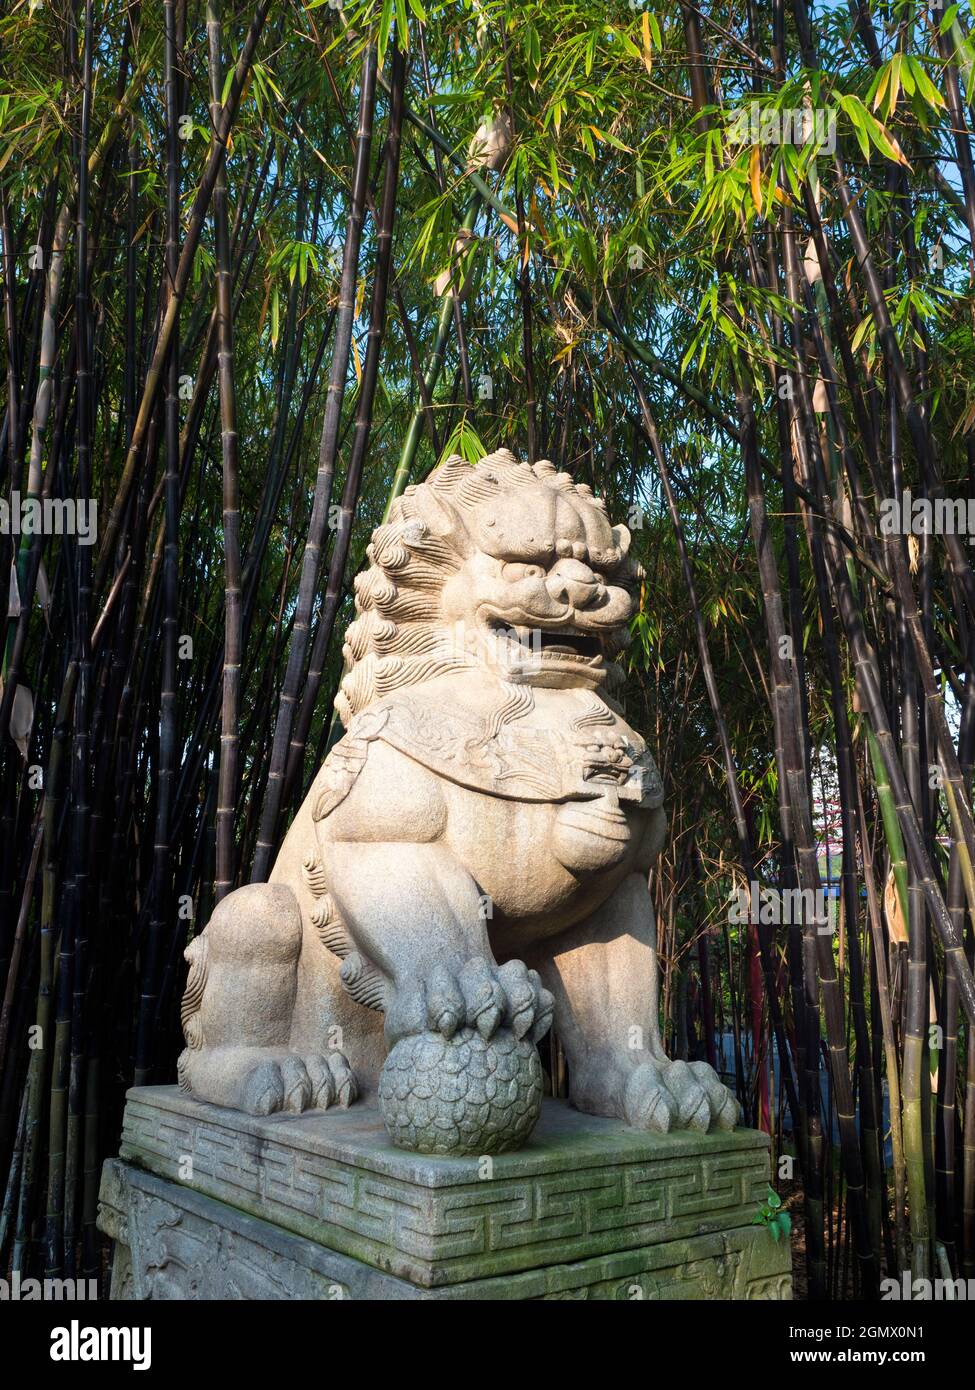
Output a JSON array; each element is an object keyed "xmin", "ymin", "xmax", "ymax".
[{"xmin": 122, "ymin": 1101, "xmax": 768, "ymax": 1262}]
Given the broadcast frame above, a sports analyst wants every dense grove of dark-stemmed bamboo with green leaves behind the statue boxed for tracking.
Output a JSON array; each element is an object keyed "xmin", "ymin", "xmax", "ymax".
[{"xmin": 0, "ymin": 0, "xmax": 975, "ymax": 1298}]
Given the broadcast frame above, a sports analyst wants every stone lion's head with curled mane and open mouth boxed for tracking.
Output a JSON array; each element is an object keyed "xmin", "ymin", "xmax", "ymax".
[{"xmin": 335, "ymin": 449, "xmax": 643, "ymax": 726}]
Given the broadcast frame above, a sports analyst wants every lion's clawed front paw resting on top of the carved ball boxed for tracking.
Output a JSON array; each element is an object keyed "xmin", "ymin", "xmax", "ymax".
[{"xmin": 387, "ymin": 956, "xmax": 554, "ymax": 1043}]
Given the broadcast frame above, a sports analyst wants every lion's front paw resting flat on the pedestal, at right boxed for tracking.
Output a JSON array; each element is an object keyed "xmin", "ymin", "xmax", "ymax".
[{"xmin": 623, "ymin": 1061, "xmax": 739, "ymax": 1134}]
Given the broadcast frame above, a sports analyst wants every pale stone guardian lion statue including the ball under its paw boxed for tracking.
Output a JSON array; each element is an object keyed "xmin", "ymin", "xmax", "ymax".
[{"xmin": 179, "ymin": 450, "xmax": 737, "ymax": 1154}]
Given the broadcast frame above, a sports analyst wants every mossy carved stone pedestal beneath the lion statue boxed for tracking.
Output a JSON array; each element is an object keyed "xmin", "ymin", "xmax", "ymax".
[{"xmin": 99, "ymin": 1087, "xmax": 791, "ymax": 1300}]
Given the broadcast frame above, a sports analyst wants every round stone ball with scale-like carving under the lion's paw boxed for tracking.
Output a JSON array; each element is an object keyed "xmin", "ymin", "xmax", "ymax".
[{"xmin": 380, "ymin": 1029, "xmax": 542, "ymax": 1155}]
